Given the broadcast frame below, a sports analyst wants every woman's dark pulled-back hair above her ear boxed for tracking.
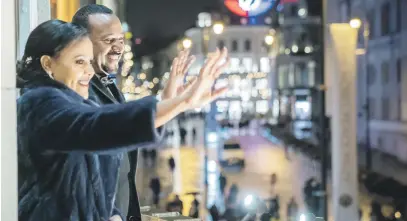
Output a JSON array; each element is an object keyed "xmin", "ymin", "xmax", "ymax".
[{"xmin": 17, "ymin": 20, "xmax": 88, "ymax": 86}]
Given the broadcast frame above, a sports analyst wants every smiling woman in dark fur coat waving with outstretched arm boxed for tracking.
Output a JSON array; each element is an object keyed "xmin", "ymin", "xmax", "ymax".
[{"xmin": 17, "ymin": 20, "xmax": 227, "ymax": 221}]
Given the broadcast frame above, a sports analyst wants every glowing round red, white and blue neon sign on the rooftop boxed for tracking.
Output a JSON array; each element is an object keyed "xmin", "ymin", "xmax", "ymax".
[{"xmin": 224, "ymin": 0, "xmax": 276, "ymax": 17}]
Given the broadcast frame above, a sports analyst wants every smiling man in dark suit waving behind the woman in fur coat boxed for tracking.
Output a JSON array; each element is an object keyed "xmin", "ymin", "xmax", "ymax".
[{"xmin": 72, "ymin": 4, "xmax": 194, "ymax": 221}]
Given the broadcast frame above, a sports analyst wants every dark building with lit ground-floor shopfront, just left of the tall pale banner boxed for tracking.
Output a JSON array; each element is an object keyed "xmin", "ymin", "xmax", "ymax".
[{"xmin": 273, "ymin": 1, "xmax": 322, "ymax": 138}]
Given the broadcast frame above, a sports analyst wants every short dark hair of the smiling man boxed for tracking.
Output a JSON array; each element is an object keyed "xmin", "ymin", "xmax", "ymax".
[{"xmin": 72, "ymin": 4, "xmax": 113, "ymax": 30}]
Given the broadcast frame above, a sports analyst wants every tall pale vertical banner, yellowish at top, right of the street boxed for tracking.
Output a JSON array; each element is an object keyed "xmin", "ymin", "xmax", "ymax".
[{"xmin": 328, "ymin": 24, "xmax": 359, "ymax": 221}]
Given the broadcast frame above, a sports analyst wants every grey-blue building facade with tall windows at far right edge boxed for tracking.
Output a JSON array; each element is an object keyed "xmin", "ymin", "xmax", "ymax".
[{"xmin": 340, "ymin": 0, "xmax": 407, "ymax": 163}]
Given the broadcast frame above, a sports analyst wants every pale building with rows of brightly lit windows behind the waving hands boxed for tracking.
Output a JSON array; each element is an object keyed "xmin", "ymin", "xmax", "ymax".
[{"xmin": 186, "ymin": 25, "xmax": 274, "ymax": 120}]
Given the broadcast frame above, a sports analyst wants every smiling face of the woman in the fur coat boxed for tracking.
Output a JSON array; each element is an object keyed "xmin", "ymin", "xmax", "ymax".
[{"xmin": 50, "ymin": 37, "xmax": 95, "ymax": 99}]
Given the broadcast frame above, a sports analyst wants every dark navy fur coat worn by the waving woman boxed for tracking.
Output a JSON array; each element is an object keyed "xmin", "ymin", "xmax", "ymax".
[{"xmin": 17, "ymin": 78, "xmax": 160, "ymax": 221}]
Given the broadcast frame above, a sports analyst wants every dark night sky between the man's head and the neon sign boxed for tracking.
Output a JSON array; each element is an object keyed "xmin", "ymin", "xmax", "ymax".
[{"xmin": 126, "ymin": 0, "xmax": 222, "ymax": 55}]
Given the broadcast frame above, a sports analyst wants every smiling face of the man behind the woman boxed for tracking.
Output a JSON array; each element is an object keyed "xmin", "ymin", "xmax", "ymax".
[{"xmin": 89, "ymin": 14, "xmax": 124, "ymax": 73}]
